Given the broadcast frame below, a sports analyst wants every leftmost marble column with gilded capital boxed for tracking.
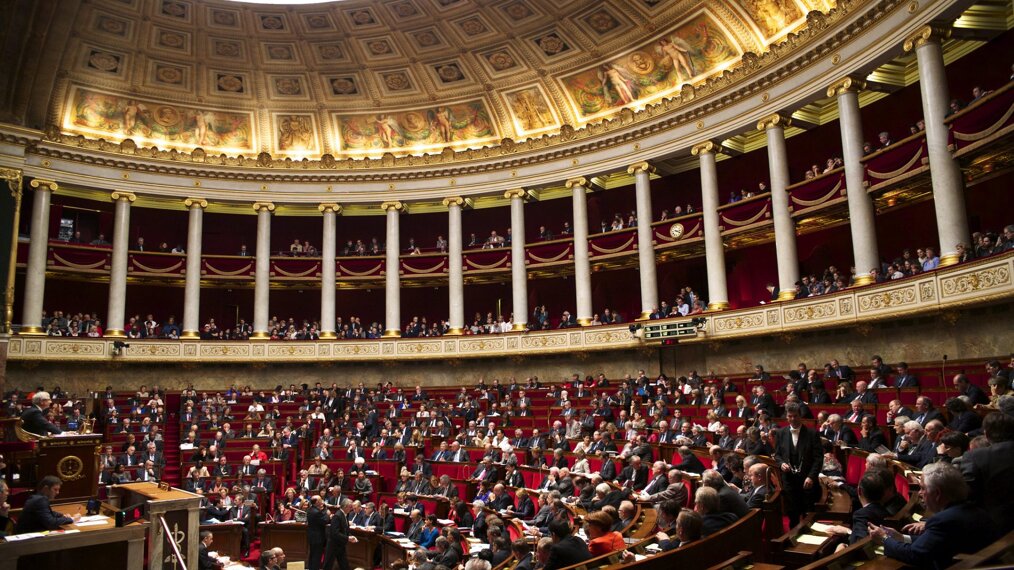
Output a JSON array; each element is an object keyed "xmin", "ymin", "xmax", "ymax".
[{"xmin": 15, "ymin": 179, "xmax": 59, "ymax": 335}]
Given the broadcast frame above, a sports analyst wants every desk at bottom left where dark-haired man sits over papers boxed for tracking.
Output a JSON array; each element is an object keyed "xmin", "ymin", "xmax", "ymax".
[{"xmin": 0, "ymin": 496, "xmax": 149, "ymax": 570}]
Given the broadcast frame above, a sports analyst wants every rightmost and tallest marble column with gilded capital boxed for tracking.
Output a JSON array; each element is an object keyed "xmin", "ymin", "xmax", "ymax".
[{"xmin": 904, "ymin": 25, "xmax": 974, "ymax": 267}]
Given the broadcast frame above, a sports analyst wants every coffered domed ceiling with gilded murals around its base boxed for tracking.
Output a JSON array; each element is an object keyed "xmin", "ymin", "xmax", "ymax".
[{"xmin": 51, "ymin": 0, "xmax": 834, "ymax": 158}]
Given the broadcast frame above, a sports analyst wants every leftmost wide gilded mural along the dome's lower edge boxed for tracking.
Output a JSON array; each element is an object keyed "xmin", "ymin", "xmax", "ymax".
[{"xmin": 64, "ymin": 87, "xmax": 257, "ymax": 152}]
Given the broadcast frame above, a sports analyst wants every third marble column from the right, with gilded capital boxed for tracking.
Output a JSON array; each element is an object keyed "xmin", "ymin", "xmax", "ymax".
[{"xmin": 757, "ymin": 114, "xmax": 799, "ymax": 300}]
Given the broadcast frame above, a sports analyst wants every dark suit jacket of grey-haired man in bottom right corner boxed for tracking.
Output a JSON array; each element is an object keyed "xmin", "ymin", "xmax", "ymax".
[{"xmin": 884, "ymin": 503, "xmax": 1000, "ymax": 568}]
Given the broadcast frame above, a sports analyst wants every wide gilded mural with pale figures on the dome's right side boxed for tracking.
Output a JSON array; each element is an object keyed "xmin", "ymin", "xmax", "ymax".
[{"xmin": 562, "ymin": 12, "xmax": 742, "ymax": 121}]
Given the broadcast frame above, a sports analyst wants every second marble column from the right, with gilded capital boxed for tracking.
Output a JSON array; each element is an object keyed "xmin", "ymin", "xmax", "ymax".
[{"xmin": 827, "ymin": 77, "xmax": 880, "ymax": 285}]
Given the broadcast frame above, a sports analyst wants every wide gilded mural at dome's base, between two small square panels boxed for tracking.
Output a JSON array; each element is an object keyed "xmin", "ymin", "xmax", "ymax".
[{"xmin": 335, "ymin": 100, "xmax": 499, "ymax": 152}]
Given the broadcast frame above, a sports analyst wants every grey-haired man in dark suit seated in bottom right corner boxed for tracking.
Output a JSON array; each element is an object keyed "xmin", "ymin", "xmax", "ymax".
[{"xmin": 868, "ymin": 462, "xmax": 1000, "ymax": 568}]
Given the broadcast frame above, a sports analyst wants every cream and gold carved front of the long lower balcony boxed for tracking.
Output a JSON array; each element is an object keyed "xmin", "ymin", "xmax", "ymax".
[{"xmin": 8, "ymin": 252, "xmax": 1014, "ymax": 363}]
